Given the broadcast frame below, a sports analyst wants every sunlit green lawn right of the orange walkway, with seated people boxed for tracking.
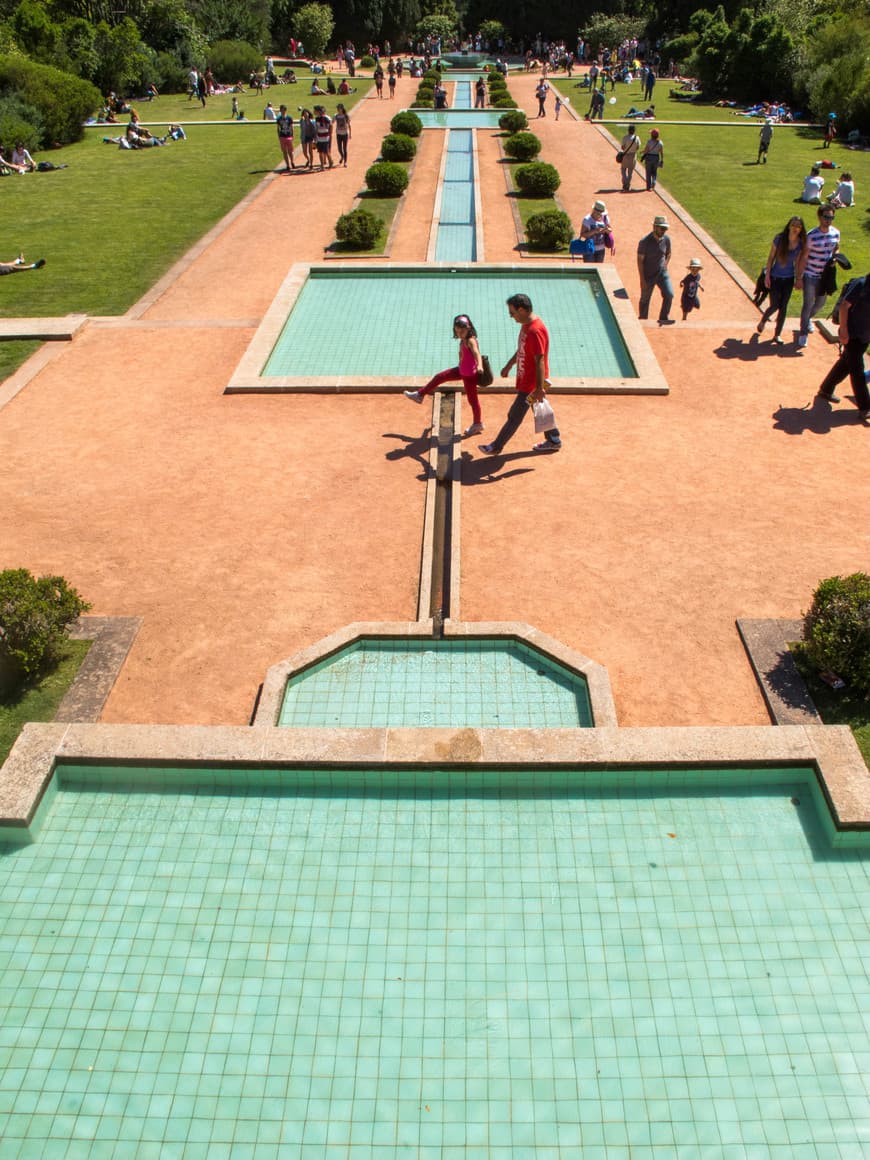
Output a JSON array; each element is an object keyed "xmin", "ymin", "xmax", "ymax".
[{"xmin": 557, "ymin": 80, "xmax": 870, "ymax": 287}]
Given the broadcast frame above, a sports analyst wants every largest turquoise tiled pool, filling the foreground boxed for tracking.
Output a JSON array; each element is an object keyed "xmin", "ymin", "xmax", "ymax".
[{"xmin": 0, "ymin": 767, "xmax": 870, "ymax": 1160}]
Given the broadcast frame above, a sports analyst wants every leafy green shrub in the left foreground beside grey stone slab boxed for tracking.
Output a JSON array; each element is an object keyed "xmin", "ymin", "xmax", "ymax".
[{"xmin": 0, "ymin": 568, "xmax": 90, "ymax": 688}]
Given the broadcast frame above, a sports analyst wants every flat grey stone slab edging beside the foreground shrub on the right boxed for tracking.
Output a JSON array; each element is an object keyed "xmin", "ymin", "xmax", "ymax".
[{"xmin": 737, "ymin": 619, "xmax": 821, "ymax": 725}]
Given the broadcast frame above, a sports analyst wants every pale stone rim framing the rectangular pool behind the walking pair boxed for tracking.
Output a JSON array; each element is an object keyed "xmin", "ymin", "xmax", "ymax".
[{"xmin": 224, "ymin": 261, "xmax": 668, "ymax": 394}]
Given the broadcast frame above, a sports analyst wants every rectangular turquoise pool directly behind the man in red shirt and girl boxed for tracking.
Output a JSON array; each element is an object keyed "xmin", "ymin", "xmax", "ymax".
[{"xmin": 262, "ymin": 267, "xmax": 637, "ymax": 378}]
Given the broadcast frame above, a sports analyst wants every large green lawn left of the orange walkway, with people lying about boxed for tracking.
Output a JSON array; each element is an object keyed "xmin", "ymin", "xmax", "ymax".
[{"xmin": 0, "ymin": 80, "xmax": 371, "ymax": 318}]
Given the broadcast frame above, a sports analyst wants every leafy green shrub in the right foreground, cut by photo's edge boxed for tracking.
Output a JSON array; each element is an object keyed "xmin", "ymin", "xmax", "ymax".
[{"xmin": 803, "ymin": 572, "xmax": 870, "ymax": 693}]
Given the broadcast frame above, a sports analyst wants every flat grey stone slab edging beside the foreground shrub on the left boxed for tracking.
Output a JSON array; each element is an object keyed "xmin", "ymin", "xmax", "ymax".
[{"xmin": 55, "ymin": 616, "xmax": 142, "ymax": 722}]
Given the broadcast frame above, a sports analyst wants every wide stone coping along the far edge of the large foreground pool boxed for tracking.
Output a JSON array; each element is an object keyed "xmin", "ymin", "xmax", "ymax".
[{"xmin": 0, "ymin": 724, "xmax": 870, "ymax": 846}]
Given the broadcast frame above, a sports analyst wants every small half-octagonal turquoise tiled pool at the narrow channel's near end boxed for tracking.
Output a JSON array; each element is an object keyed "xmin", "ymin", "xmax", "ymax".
[{"xmin": 278, "ymin": 638, "xmax": 593, "ymax": 728}]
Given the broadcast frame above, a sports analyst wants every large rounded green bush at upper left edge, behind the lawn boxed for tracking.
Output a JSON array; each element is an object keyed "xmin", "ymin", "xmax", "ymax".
[{"xmin": 0, "ymin": 57, "xmax": 102, "ymax": 145}]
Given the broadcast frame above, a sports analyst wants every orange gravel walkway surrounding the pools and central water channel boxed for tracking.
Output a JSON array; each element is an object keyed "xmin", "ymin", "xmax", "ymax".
[{"xmin": 0, "ymin": 77, "xmax": 870, "ymax": 725}]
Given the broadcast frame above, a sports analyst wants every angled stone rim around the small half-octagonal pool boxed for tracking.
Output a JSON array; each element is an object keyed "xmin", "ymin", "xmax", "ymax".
[{"xmin": 252, "ymin": 618, "xmax": 616, "ymax": 732}]
